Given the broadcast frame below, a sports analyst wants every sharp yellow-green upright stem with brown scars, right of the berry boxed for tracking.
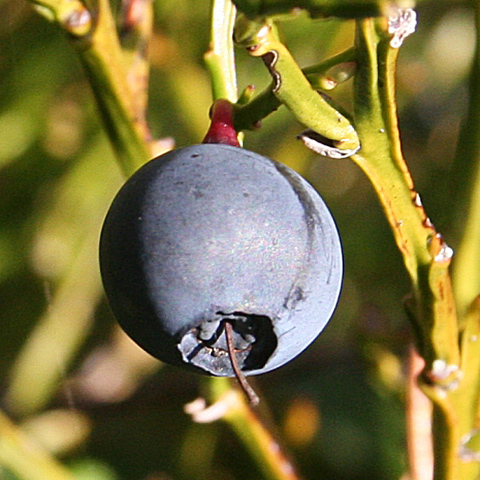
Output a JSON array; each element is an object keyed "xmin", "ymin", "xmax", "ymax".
[{"xmin": 352, "ymin": 19, "xmax": 460, "ymax": 480}]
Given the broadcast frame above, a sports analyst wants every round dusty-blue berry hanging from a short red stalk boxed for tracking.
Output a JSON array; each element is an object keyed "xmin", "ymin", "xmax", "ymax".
[{"xmin": 100, "ymin": 144, "xmax": 342, "ymax": 376}]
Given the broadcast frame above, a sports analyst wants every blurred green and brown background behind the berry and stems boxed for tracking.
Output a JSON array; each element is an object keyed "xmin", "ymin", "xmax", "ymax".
[{"xmin": 0, "ymin": 0, "xmax": 475, "ymax": 480}]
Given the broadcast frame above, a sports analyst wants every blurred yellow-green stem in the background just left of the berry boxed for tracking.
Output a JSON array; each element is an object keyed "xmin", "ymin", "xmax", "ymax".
[{"xmin": 5, "ymin": 138, "xmax": 121, "ymax": 417}]
